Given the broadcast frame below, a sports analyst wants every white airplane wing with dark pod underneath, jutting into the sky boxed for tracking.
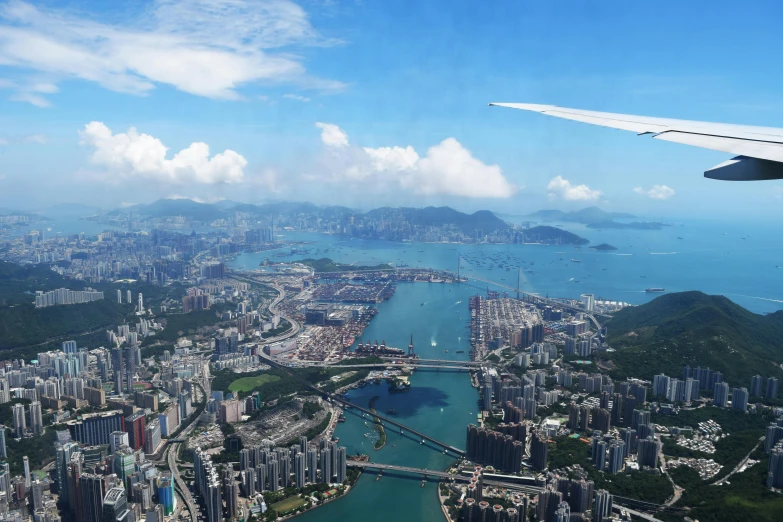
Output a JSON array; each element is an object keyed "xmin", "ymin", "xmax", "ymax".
[{"xmin": 490, "ymin": 103, "xmax": 783, "ymax": 181}]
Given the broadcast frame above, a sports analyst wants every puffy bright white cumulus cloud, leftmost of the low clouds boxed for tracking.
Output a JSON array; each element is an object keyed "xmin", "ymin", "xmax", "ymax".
[{"xmin": 79, "ymin": 121, "xmax": 247, "ymax": 185}]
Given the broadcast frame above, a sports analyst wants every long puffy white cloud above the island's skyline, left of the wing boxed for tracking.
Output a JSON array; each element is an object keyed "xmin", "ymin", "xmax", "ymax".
[{"xmin": 316, "ymin": 122, "xmax": 517, "ymax": 198}]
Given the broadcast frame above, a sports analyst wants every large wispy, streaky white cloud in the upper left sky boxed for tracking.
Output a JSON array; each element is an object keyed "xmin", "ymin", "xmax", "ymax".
[{"xmin": 0, "ymin": 0, "xmax": 345, "ymax": 106}]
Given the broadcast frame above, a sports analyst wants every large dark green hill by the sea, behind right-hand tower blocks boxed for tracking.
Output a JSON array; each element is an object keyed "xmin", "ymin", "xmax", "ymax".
[{"xmin": 606, "ymin": 292, "xmax": 783, "ymax": 386}]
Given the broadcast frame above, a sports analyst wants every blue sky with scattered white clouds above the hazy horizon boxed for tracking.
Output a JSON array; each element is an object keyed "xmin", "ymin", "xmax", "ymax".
[{"xmin": 0, "ymin": 0, "xmax": 783, "ymax": 218}]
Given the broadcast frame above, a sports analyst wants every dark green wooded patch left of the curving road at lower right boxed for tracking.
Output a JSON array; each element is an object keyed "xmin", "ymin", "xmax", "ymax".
[{"xmin": 549, "ymin": 437, "xmax": 674, "ymax": 504}]
